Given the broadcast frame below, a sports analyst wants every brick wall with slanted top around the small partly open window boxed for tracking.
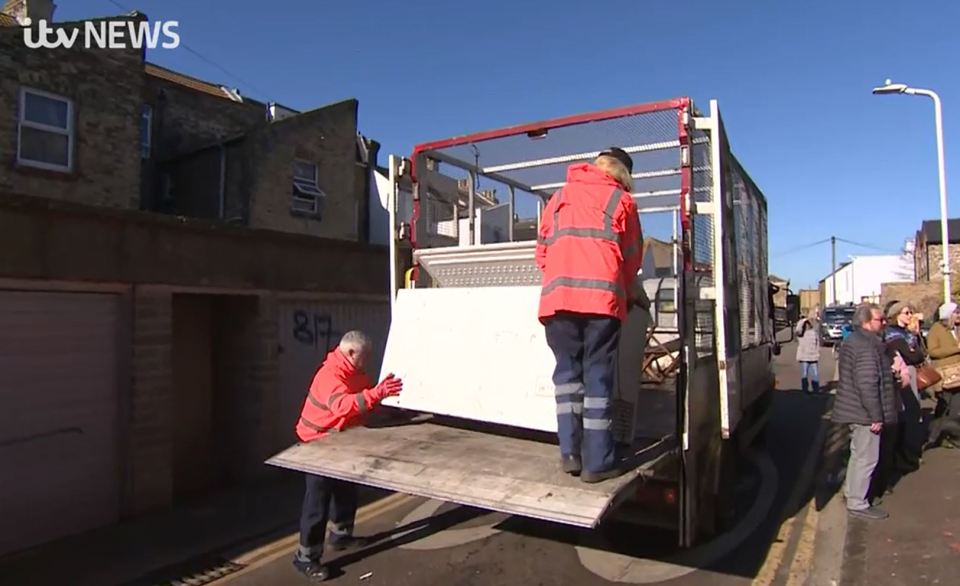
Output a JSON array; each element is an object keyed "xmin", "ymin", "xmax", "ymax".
[{"xmin": 246, "ymin": 100, "xmax": 366, "ymax": 241}]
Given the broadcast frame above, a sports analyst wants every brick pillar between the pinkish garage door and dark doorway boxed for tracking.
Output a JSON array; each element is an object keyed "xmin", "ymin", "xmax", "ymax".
[{"xmin": 123, "ymin": 287, "xmax": 173, "ymax": 516}]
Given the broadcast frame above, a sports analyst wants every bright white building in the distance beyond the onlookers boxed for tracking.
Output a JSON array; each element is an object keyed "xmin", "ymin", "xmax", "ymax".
[{"xmin": 820, "ymin": 254, "xmax": 913, "ymax": 306}]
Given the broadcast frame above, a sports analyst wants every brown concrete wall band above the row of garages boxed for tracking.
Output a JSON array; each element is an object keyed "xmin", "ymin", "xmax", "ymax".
[{"xmin": 0, "ymin": 194, "xmax": 389, "ymax": 295}]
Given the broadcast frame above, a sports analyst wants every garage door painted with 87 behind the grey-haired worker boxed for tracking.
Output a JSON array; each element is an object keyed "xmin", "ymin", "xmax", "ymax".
[{"xmin": 274, "ymin": 301, "xmax": 390, "ymax": 449}]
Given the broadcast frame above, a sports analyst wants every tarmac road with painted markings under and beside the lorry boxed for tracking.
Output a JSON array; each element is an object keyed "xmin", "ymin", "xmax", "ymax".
[{"xmin": 167, "ymin": 345, "xmax": 834, "ymax": 586}]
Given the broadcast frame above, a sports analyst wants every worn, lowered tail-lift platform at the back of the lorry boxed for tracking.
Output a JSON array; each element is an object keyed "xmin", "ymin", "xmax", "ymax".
[{"xmin": 267, "ymin": 421, "xmax": 674, "ymax": 528}]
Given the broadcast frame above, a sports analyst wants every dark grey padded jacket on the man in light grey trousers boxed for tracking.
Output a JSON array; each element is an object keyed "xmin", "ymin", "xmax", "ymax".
[{"xmin": 832, "ymin": 328, "xmax": 899, "ymax": 425}]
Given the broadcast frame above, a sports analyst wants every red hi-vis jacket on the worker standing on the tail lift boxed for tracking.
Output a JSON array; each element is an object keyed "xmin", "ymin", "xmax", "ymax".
[{"xmin": 536, "ymin": 163, "xmax": 643, "ymax": 321}]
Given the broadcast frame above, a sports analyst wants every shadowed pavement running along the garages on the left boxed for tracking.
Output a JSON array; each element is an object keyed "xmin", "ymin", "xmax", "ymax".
[{"xmin": 0, "ymin": 474, "xmax": 385, "ymax": 586}]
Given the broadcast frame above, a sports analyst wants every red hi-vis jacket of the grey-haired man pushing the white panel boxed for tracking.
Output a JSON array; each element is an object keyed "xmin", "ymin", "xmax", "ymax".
[{"xmin": 297, "ymin": 348, "xmax": 376, "ymax": 442}]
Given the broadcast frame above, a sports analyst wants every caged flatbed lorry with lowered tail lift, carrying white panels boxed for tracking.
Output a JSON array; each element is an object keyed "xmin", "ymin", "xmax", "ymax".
[{"xmin": 267, "ymin": 98, "xmax": 777, "ymax": 546}]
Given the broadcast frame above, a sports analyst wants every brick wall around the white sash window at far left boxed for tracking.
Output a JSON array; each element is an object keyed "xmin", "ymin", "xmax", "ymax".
[{"xmin": 0, "ymin": 18, "xmax": 144, "ymax": 208}]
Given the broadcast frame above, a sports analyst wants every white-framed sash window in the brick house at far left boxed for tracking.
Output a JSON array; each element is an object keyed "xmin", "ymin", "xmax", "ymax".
[{"xmin": 17, "ymin": 88, "xmax": 74, "ymax": 171}]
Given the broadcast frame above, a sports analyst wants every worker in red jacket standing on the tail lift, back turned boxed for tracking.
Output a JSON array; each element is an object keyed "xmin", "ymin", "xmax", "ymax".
[{"xmin": 536, "ymin": 147, "xmax": 643, "ymax": 482}]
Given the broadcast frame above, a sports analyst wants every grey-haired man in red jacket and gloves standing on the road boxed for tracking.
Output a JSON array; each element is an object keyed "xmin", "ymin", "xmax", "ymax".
[{"xmin": 293, "ymin": 331, "xmax": 403, "ymax": 581}]
